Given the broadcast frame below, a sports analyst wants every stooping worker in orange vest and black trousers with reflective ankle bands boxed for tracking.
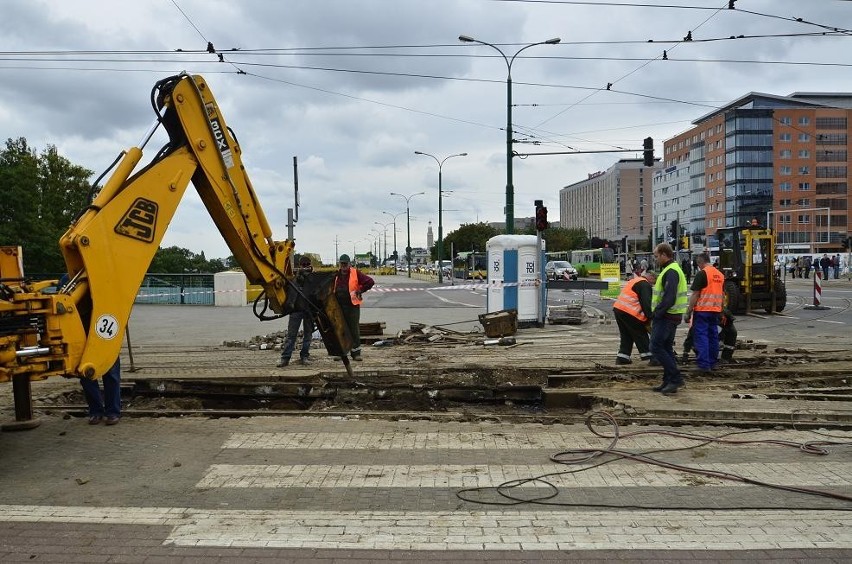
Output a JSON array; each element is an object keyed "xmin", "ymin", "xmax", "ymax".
[{"xmin": 612, "ymin": 270, "xmax": 657, "ymax": 364}]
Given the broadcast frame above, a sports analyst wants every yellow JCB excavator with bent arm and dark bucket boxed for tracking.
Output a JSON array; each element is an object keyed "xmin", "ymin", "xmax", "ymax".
[{"xmin": 0, "ymin": 74, "xmax": 352, "ymax": 394}]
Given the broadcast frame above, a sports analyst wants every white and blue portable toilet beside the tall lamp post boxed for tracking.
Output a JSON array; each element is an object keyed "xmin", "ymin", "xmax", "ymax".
[{"xmin": 485, "ymin": 235, "xmax": 546, "ymax": 325}]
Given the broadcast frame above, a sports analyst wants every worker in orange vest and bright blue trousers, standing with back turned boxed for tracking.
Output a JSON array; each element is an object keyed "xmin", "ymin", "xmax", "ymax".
[{"xmin": 683, "ymin": 253, "xmax": 725, "ymax": 373}]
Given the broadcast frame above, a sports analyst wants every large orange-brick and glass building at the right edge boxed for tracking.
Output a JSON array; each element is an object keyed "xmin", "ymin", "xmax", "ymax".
[{"xmin": 653, "ymin": 92, "xmax": 852, "ymax": 253}]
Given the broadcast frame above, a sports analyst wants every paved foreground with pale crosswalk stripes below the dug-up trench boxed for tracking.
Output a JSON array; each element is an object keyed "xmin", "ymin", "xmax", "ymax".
[{"xmin": 0, "ymin": 416, "xmax": 852, "ymax": 562}]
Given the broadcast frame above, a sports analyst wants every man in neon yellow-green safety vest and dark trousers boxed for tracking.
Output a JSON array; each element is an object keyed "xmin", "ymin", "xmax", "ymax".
[{"xmin": 651, "ymin": 243, "xmax": 687, "ymax": 395}]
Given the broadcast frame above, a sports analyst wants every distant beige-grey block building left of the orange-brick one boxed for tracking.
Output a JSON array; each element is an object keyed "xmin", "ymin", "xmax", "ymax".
[{"xmin": 551, "ymin": 159, "xmax": 662, "ymax": 247}]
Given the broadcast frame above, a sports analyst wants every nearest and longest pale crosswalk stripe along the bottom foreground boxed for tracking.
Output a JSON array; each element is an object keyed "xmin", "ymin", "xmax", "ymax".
[{"xmin": 0, "ymin": 505, "xmax": 852, "ymax": 551}]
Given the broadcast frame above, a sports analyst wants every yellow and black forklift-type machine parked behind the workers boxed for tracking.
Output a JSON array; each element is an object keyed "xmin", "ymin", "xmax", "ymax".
[{"xmin": 716, "ymin": 222, "xmax": 787, "ymax": 313}]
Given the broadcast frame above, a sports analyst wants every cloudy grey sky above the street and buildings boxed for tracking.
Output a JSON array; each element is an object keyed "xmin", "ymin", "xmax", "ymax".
[{"xmin": 0, "ymin": 0, "xmax": 852, "ymax": 262}]
